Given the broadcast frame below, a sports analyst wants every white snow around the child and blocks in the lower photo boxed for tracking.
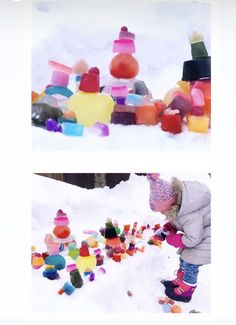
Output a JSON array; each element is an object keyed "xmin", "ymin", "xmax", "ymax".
[{"xmin": 31, "ymin": 174, "xmax": 211, "ymax": 314}]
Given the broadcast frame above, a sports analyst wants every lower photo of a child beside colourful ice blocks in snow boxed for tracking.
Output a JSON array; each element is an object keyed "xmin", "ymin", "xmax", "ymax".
[{"xmin": 31, "ymin": 171, "xmax": 211, "ymax": 314}]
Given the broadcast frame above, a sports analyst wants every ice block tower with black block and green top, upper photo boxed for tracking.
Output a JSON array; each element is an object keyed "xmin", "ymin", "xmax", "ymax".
[{"xmin": 161, "ymin": 32, "xmax": 211, "ymax": 134}]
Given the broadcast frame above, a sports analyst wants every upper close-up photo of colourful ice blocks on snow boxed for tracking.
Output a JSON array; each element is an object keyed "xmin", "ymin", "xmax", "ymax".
[{"xmin": 31, "ymin": 0, "xmax": 211, "ymax": 151}]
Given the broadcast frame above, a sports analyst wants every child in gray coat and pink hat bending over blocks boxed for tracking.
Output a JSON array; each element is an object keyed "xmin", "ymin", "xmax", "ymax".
[{"xmin": 147, "ymin": 174, "xmax": 211, "ymax": 302}]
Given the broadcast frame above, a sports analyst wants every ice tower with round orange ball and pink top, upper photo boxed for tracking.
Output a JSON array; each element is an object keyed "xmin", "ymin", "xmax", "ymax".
[{"xmin": 110, "ymin": 26, "xmax": 166, "ymax": 125}]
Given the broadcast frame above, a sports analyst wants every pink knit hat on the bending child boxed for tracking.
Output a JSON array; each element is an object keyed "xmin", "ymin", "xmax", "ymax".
[{"xmin": 147, "ymin": 174, "xmax": 176, "ymax": 212}]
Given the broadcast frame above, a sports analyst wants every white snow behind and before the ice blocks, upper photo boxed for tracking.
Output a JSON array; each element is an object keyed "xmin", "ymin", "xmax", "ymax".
[{"xmin": 32, "ymin": 1, "xmax": 211, "ymax": 150}]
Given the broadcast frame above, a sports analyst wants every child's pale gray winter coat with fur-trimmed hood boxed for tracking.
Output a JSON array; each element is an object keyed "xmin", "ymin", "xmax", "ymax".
[{"xmin": 163, "ymin": 178, "xmax": 211, "ymax": 264}]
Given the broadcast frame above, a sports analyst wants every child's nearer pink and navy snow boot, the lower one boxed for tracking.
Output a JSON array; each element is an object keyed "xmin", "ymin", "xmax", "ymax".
[{"xmin": 165, "ymin": 280, "xmax": 197, "ymax": 302}]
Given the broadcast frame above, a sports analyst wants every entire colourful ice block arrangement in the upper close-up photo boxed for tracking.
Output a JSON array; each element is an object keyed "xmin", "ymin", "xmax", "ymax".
[{"xmin": 32, "ymin": 26, "xmax": 211, "ymax": 136}]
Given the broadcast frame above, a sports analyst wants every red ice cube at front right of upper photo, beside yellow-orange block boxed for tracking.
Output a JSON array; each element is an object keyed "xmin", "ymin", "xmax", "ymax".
[{"xmin": 161, "ymin": 110, "xmax": 182, "ymax": 134}]
